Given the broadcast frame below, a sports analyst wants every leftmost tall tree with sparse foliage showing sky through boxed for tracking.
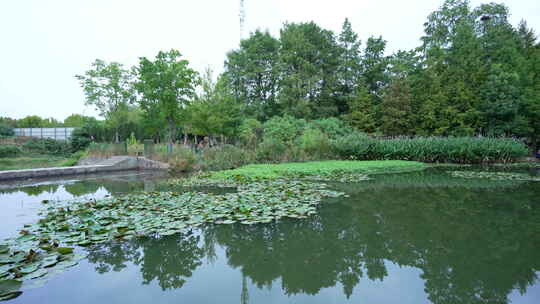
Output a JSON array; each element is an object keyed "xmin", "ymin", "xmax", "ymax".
[{"xmin": 75, "ymin": 59, "xmax": 135, "ymax": 142}]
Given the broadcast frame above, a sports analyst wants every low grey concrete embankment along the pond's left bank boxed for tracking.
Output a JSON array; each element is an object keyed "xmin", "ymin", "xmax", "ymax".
[{"xmin": 0, "ymin": 156, "xmax": 168, "ymax": 180}]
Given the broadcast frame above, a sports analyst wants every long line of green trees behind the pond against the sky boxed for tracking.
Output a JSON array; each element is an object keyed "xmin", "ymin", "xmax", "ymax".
[{"xmin": 2, "ymin": 0, "xmax": 540, "ymax": 150}]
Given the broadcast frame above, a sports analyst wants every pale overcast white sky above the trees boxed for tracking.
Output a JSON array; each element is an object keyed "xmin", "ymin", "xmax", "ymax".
[{"xmin": 0, "ymin": 0, "xmax": 540, "ymax": 120}]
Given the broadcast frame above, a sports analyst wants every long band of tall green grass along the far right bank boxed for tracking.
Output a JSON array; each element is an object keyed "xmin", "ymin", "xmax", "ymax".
[{"xmin": 332, "ymin": 134, "xmax": 528, "ymax": 164}]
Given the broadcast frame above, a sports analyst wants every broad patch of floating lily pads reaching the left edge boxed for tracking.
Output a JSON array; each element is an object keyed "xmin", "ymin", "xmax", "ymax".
[{"xmin": 0, "ymin": 180, "xmax": 342, "ymax": 300}]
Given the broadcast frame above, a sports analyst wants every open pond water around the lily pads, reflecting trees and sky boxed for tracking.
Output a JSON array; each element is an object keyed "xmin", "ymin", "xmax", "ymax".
[{"xmin": 0, "ymin": 169, "xmax": 540, "ymax": 304}]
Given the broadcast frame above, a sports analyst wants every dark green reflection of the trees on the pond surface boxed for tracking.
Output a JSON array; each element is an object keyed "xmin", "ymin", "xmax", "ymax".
[{"xmin": 84, "ymin": 177, "xmax": 540, "ymax": 304}]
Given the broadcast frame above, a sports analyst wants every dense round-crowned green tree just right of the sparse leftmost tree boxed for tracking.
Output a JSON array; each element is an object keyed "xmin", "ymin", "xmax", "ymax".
[{"xmin": 135, "ymin": 50, "xmax": 198, "ymax": 144}]
